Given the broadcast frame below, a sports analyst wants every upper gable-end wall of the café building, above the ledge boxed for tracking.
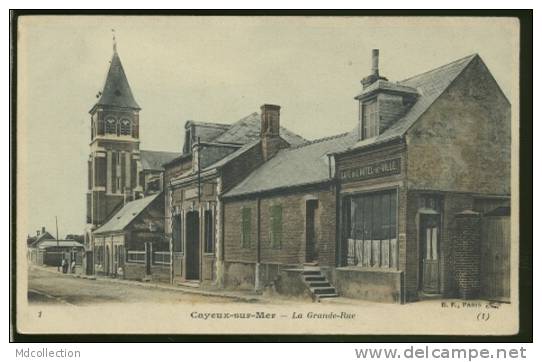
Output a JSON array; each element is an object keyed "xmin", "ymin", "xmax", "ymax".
[{"xmin": 407, "ymin": 55, "xmax": 511, "ymax": 195}]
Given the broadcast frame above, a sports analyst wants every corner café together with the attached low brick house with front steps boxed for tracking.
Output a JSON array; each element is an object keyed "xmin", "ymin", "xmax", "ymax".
[{"xmin": 223, "ymin": 50, "xmax": 511, "ymax": 302}]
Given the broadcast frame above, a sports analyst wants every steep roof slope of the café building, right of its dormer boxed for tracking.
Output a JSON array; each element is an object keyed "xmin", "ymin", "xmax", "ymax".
[{"xmin": 350, "ymin": 54, "xmax": 478, "ymax": 149}]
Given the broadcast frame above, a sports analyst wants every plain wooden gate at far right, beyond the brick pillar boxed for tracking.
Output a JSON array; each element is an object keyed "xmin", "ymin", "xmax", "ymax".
[{"xmin": 480, "ymin": 216, "xmax": 510, "ymax": 301}]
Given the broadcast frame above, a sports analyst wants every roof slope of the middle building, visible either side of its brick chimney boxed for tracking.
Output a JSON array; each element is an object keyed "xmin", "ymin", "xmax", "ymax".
[{"xmin": 214, "ymin": 112, "xmax": 306, "ymax": 145}]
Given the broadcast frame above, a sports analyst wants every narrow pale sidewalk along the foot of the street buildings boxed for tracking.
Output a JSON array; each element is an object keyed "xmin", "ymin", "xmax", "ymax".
[{"xmin": 29, "ymin": 264, "xmax": 269, "ymax": 303}]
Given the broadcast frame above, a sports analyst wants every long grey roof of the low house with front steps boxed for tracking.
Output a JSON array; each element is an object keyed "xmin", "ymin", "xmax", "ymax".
[{"xmin": 225, "ymin": 132, "xmax": 357, "ymax": 197}]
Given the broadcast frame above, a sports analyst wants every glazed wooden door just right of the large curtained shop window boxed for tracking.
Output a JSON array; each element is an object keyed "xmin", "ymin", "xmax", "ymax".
[{"xmin": 420, "ymin": 215, "xmax": 440, "ymax": 294}]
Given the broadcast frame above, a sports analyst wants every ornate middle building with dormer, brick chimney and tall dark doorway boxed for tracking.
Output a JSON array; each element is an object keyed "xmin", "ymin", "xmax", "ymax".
[{"xmin": 164, "ymin": 109, "xmax": 305, "ymax": 286}]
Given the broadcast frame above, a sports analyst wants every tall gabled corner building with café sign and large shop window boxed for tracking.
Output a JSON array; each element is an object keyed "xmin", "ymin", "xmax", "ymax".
[{"xmin": 333, "ymin": 50, "xmax": 511, "ymax": 302}]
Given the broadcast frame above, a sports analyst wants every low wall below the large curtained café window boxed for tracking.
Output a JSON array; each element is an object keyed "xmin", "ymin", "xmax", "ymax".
[{"xmin": 332, "ymin": 267, "xmax": 404, "ymax": 303}]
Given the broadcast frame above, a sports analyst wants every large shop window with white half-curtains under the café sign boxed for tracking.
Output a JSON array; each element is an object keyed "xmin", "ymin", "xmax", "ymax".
[{"xmin": 348, "ymin": 191, "xmax": 397, "ymax": 268}]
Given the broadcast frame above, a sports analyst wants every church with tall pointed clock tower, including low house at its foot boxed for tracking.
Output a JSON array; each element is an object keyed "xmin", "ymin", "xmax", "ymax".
[{"xmin": 85, "ymin": 43, "xmax": 179, "ymax": 275}]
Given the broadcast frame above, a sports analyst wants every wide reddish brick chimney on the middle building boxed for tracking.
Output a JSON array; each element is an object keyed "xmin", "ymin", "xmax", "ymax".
[{"xmin": 260, "ymin": 104, "xmax": 288, "ymax": 161}]
